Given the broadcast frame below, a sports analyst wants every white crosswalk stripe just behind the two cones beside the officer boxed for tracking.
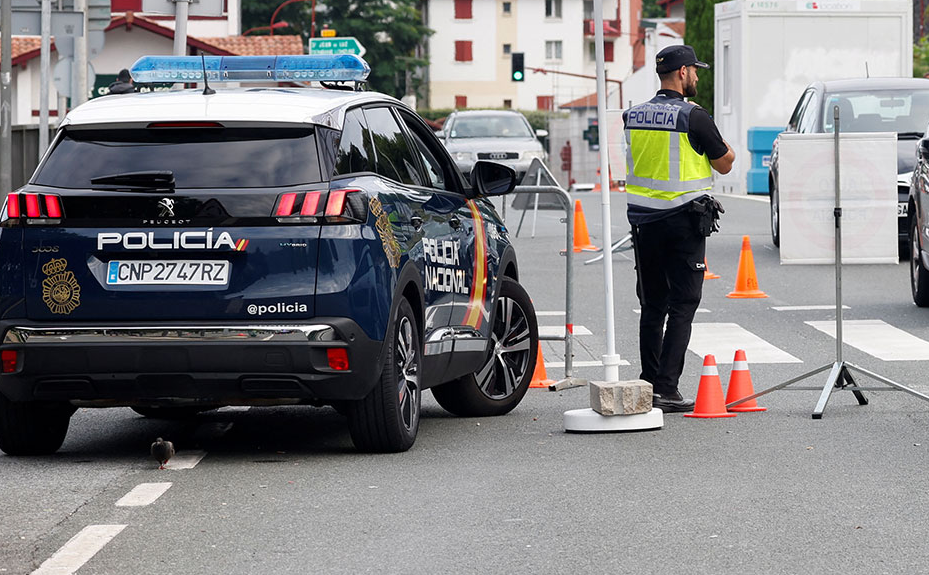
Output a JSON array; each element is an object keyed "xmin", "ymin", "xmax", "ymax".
[{"xmin": 687, "ymin": 323, "xmax": 803, "ymax": 365}]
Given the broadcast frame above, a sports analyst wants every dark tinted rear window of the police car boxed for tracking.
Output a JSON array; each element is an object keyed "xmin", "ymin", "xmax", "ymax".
[{"xmin": 33, "ymin": 127, "xmax": 321, "ymax": 188}]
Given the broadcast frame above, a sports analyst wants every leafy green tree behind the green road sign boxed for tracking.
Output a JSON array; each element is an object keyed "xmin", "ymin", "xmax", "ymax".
[{"xmin": 242, "ymin": 0, "xmax": 432, "ymax": 98}]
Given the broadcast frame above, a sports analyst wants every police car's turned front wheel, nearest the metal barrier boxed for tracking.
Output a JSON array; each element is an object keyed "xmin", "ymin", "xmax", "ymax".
[{"xmin": 432, "ymin": 278, "xmax": 539, "ymax": 417}]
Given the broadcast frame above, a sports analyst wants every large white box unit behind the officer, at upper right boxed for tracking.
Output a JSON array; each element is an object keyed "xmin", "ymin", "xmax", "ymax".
[{"xmin": 716, "ymin": 0, "xmax": 913, "ymax": 193}]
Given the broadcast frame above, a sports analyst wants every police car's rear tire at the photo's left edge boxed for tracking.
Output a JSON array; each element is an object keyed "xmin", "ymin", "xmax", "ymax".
[{"xmin": 0, "ymin": 395, "xmax": 75, "ymax": 455}]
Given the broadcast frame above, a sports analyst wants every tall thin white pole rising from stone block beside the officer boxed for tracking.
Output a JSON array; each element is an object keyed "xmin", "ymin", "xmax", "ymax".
[{"xmin": 594, "ymin": 0, "xmax": 619, "ymax": 388}]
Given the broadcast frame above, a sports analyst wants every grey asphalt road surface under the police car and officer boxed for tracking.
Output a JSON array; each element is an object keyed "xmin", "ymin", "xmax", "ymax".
[{"xmin": 0, "ymin": 193, "xmax": 929, "ymax": 575}]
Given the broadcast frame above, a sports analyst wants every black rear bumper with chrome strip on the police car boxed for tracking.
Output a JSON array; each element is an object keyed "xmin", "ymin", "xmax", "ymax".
[{"xmin": 0, "ymin": 318, "xmax": 382, "ymax": 406}]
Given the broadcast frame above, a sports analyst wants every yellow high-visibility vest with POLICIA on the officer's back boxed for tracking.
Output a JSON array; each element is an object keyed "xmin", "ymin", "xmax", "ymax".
[{"xmin": 623, "ymin": 94, "xmax": 713, "ymax": 214}]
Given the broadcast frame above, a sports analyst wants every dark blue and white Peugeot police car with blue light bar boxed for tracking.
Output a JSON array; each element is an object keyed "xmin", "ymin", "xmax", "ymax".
[{"xmin": 0, "ymin": 55, "xmax": 538, "ymax": 455}]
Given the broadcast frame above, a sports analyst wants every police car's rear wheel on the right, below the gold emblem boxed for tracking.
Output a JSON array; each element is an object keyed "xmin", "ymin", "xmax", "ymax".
[{"xmin": 348, "ymin": 300, "xmax": 423, "ymax": 453}]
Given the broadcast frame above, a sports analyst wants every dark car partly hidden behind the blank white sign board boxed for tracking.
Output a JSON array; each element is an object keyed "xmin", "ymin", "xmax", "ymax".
[{"xmin": 768, "ymin": 78, "xmax": 929, "ymax": 251}]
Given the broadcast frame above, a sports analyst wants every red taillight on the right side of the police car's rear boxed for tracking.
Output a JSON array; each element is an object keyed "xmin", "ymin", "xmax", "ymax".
[{"xmin": 274, "ymin": 190, "xmax": 368, "ymax": 223}]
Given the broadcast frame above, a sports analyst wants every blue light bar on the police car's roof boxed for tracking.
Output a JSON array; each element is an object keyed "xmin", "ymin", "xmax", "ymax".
[{"xmin": 129, "ymin": 54, "xmax": 371, "ymax": 84}]
